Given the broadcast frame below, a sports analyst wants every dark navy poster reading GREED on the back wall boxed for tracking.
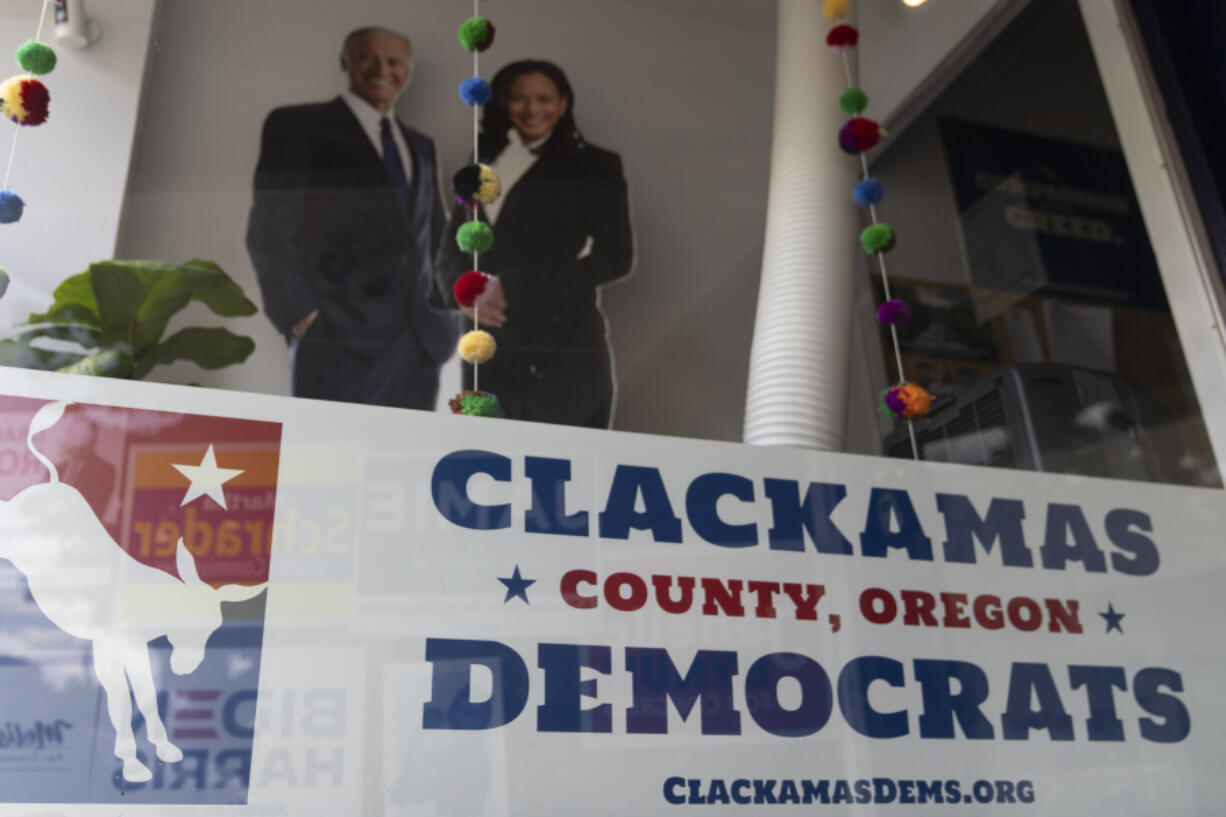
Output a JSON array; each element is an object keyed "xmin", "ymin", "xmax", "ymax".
[{"xmin": 939, "ymin": 118, "xmax": 1166, "ymax": 310}]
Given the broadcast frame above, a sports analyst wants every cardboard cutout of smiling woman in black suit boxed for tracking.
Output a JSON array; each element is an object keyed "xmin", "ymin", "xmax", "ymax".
[{"xmin": 436, "ymin": 60, "xmax": 634, "ymax": 428}]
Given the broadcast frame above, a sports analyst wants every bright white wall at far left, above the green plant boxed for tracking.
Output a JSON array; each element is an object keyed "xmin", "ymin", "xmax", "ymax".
[{"xmin": 0, "ymin": 0, "xmax": 154, "ymax": 328}]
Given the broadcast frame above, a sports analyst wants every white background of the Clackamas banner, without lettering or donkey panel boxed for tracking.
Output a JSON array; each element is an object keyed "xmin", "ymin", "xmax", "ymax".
[{"xmin": 0, "ymin": 369, "xmax": 1226, "ymax": 817}]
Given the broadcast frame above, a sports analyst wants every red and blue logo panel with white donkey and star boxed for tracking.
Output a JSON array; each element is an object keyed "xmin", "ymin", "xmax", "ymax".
[{"xmin": 0, "ymin": 396, "xmax": 281, "ymax": 804}]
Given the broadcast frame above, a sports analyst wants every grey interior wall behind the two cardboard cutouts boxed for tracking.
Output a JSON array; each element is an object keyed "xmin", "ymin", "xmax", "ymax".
[{"xmin": 119, "ymin": 0, "xmax": 775, "ymax": 439}]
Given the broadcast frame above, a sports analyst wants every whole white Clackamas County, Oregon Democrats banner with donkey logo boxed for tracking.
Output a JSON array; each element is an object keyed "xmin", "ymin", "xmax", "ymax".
[{"xmin": 0, "ymin": 370, "xmax": 1226, "ymax": 816}]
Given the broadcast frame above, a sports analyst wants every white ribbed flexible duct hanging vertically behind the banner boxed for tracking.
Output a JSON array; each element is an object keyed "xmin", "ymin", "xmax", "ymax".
[{"xmin": 744, "ymin": 0, "xmax": 858, "ymax": 450}]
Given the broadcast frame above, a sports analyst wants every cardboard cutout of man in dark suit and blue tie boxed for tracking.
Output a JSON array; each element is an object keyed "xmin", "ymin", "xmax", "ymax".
[{"xmin": 246, "ymin": 28, "xmax": 459, "ymax": 409}]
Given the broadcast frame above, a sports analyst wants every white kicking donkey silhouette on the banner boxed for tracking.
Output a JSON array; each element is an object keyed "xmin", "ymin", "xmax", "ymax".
[{"xmin": 0, "ymin": 402, "xmax": 265, "ymax": 783}]
